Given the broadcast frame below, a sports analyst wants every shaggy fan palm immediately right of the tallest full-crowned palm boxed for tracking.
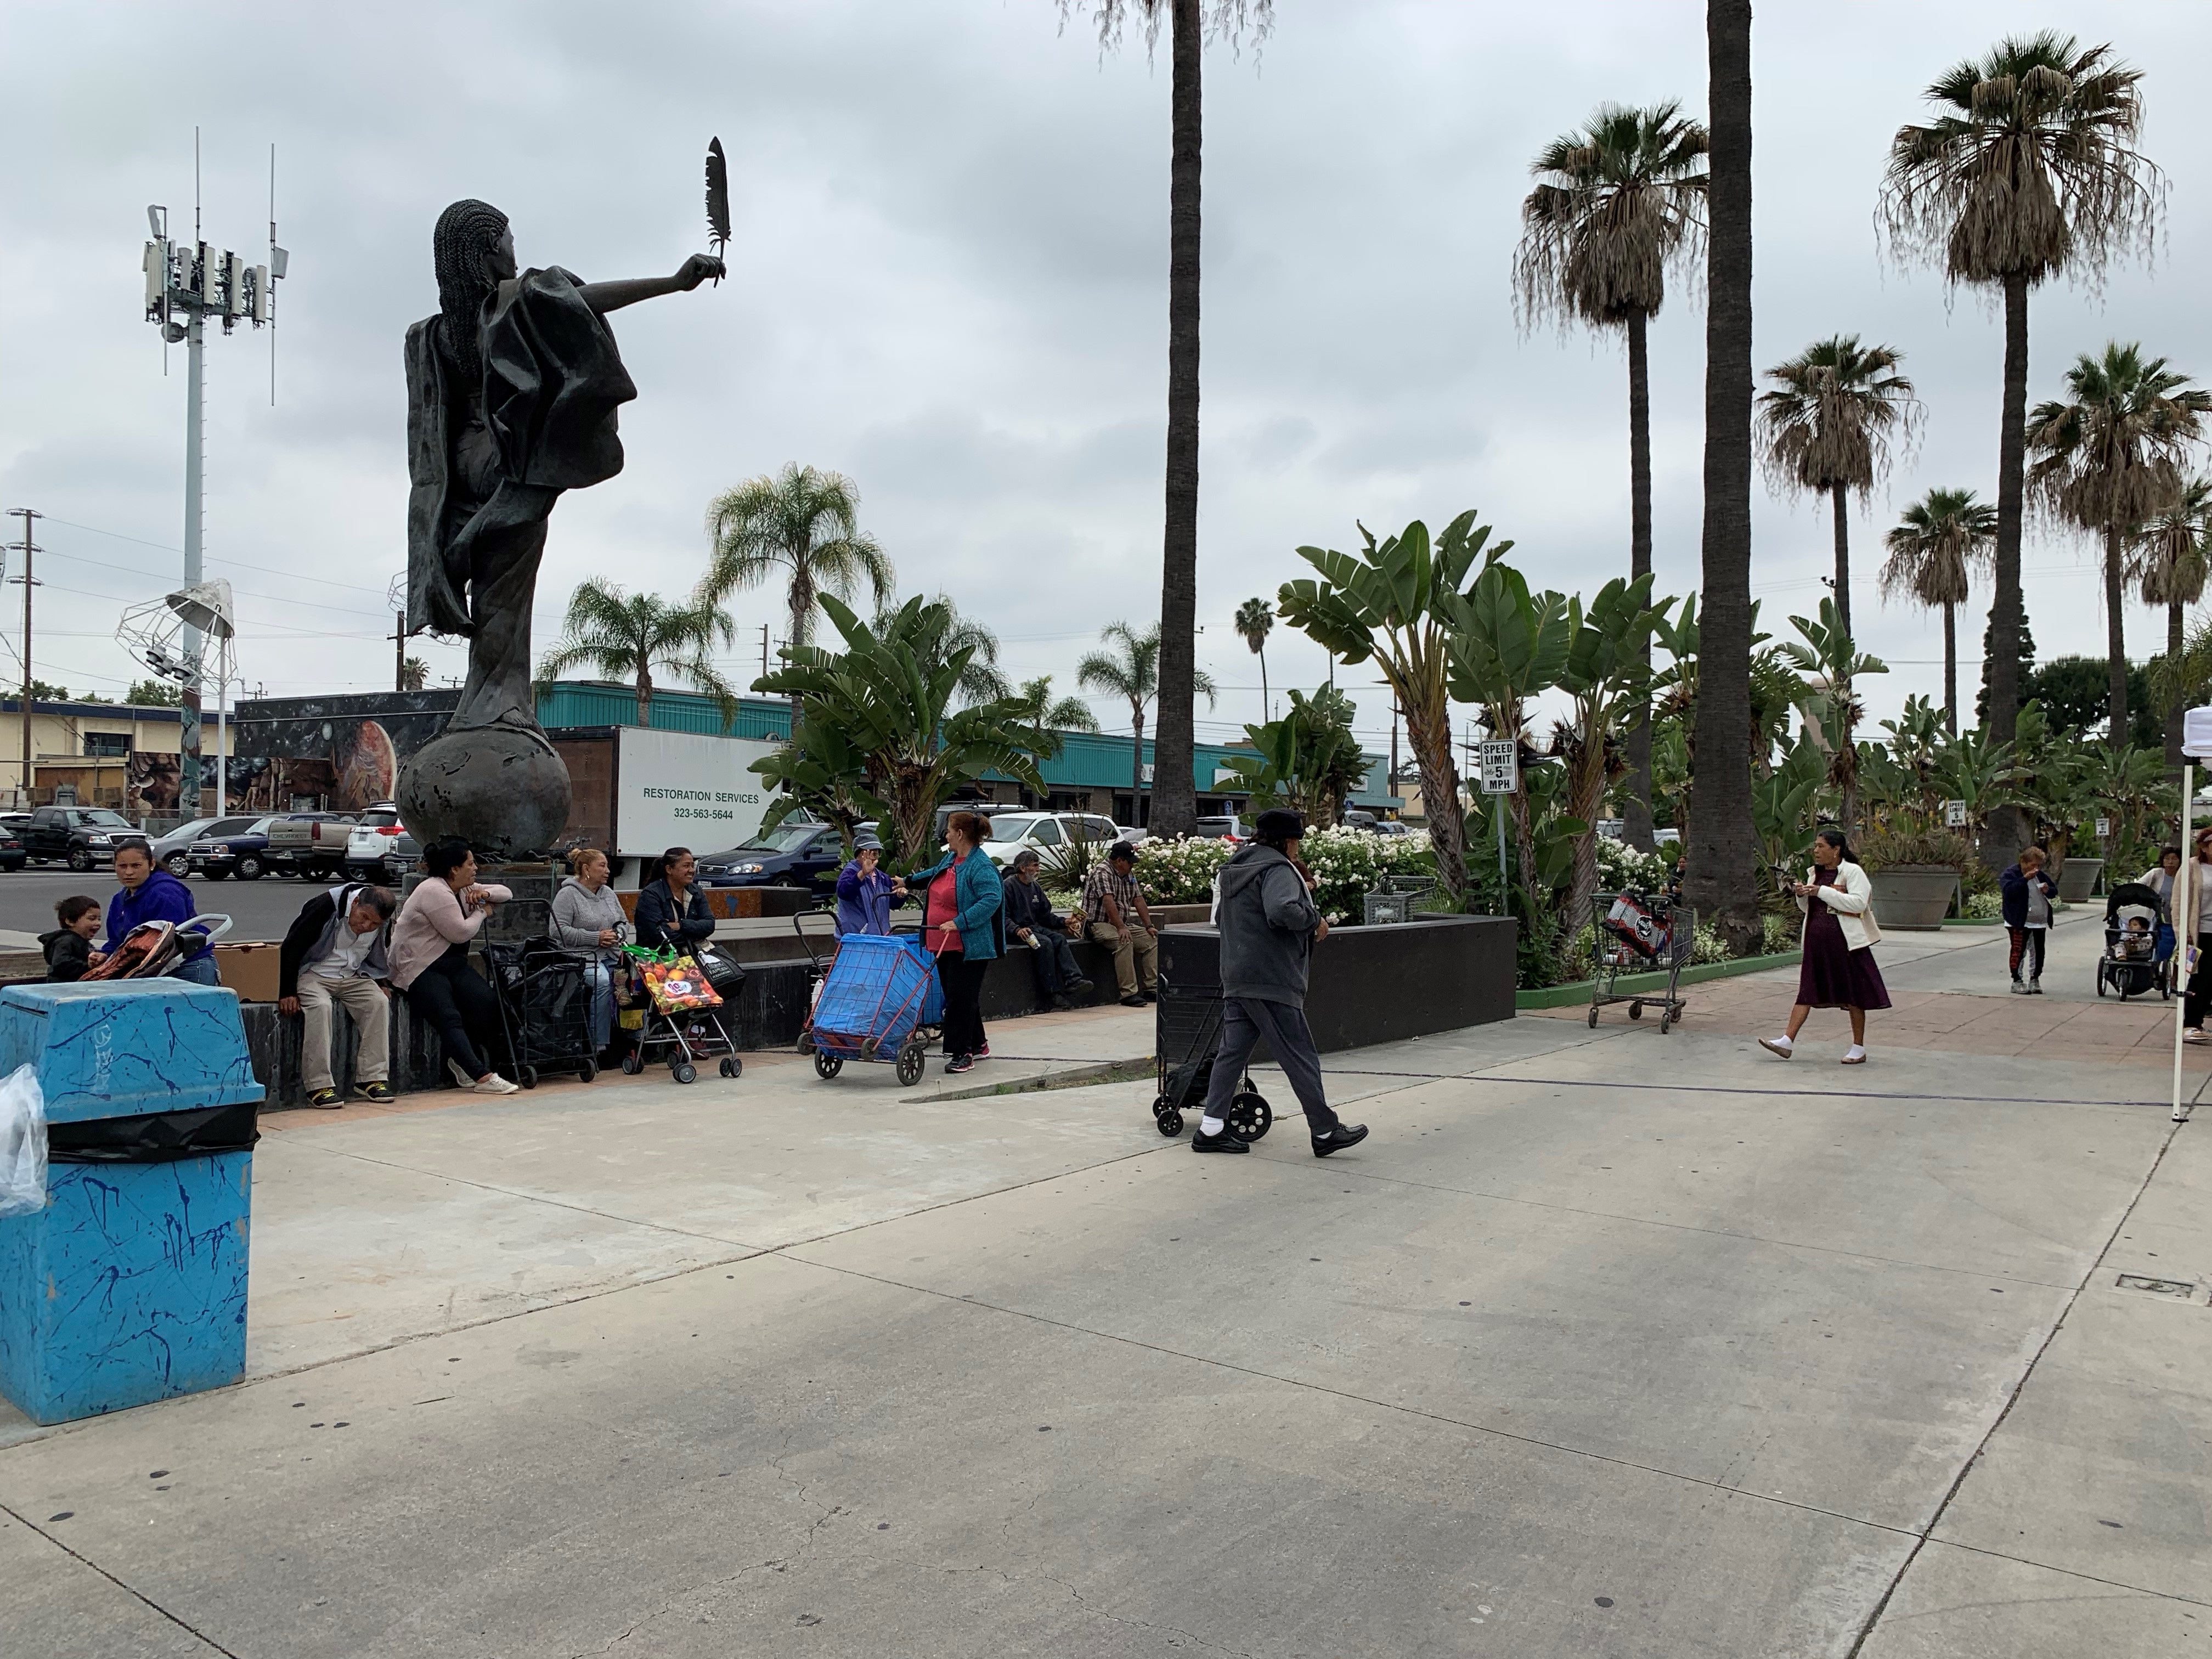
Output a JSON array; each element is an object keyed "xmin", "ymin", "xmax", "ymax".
[{"xmin": 2026, "ymin": 341, "xmax": 2212, "ymax": 748}]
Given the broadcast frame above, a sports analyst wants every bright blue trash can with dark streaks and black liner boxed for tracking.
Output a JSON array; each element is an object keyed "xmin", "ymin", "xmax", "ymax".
[{"xmin": 0, "ymin": 980, "xmax": 263, "ymax": 1423}]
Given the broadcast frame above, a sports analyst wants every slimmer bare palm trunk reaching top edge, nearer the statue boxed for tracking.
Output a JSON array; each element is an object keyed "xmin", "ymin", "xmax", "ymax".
[{"xmin": 1153, "ymin": 0, "xmax": 1205, "ymax": 836}]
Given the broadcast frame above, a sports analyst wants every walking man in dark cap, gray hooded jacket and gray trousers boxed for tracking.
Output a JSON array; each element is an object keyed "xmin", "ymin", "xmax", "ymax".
[{"xmin": 1190, "ymin": 808, "xmax": 1367, "ymax": 1157}]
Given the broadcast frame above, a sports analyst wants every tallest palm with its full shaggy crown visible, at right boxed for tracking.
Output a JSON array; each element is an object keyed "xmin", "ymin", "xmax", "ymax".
[{"xmin": 1880, "ymin": 29, "xmax": 2161, "ymax": 836}]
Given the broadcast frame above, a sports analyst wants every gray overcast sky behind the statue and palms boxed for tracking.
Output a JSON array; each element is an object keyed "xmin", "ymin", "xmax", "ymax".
[{"xmin": 0, "ymin": 0, "xmax": 2212, "ymax": 752}]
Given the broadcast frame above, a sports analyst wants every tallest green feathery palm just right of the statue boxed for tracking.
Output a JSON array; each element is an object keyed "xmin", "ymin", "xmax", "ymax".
[{"xmin": 697, "ymin": 462, "xmax": 894, "ymax": 721}]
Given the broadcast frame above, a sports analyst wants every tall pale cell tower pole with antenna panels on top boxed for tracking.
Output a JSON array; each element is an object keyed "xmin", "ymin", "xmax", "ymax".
[{"xmin": 144, "ymin": 128, "xmax": 290, "ymax": 816}]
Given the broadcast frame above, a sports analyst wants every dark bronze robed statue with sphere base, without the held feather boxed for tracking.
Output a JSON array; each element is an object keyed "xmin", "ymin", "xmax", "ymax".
[{"xmin": 398, "ymin": 201, "xmax": 723, "ymax": 858}]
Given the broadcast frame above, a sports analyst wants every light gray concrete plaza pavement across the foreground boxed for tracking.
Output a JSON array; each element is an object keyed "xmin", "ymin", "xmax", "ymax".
[{"xmin": 0, "ymin": 922, "xmax": 2212, "ymax": 1659}]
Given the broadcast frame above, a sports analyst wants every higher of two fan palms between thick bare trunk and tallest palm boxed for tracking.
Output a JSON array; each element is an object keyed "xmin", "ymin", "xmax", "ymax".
[{"xmin": 1758, "ymin": 334, "xmax": 1920, "ymax": 641}]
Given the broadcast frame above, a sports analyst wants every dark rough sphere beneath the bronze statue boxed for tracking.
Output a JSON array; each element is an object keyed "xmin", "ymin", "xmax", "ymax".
[{"xmin": 398, "ymin": 725, "xmax": 568, "ymax": 858}]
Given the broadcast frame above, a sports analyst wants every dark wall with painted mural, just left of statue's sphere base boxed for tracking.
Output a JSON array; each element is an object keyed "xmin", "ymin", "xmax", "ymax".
[{"xmin": 230, "ymin": 690, "xmax": 460, "ymax": 812}]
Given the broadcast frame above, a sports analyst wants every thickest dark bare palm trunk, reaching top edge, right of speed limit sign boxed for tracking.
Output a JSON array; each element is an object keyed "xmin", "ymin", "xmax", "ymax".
[{"xmin": 1681, "ymin": 0, "xmax": 1763, "ymax": 956}]
